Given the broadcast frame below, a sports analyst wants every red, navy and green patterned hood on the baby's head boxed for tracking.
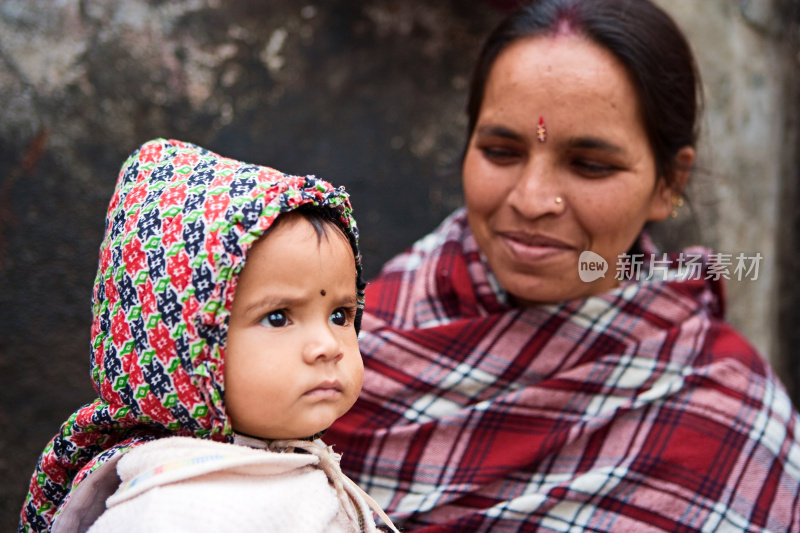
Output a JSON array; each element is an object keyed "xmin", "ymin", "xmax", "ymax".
[{"xmin": 21, "ymin": 139, "xmax": 364, "ymax": 530}]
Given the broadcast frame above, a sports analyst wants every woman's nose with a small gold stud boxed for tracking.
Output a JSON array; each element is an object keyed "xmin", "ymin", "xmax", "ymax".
[{"xmin": 506, "ymin": 160, "xmax": 566, "ymax": 219}]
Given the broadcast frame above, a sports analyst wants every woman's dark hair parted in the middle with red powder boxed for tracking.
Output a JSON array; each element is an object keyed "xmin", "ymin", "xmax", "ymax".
[{"xmin": 467, "ymin": 0, "xmax": 703, "ymax": 185}]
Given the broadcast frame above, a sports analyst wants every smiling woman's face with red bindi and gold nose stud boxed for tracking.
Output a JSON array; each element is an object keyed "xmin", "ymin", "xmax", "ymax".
[{"xmin": 463, "ymin": 35, "xmax": 672, "ymax": 304}]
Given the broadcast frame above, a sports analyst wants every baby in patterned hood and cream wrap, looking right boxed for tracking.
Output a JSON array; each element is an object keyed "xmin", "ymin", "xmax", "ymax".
[{"xmin": 20, "ymin": 139, "xmax": 396, "ymax": 533}]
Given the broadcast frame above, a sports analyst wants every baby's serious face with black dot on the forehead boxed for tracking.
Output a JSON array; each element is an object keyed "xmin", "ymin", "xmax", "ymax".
[{"xmin": 225, "ymin": 214, "xmax": 364, "ymax": 439}]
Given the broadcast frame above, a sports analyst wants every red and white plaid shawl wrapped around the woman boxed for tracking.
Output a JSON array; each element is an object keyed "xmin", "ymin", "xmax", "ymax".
[{"xmin": 326, "ymin": 211, "xmax": 800, "ymax": 533}]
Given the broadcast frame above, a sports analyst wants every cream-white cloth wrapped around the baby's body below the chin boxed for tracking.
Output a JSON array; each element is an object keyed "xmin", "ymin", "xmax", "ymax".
[{"xmin": 83, "ymin": 436, "xmax": 386, "ymax": 533}]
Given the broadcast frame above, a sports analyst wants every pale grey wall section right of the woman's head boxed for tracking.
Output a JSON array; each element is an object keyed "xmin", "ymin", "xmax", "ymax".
[{"xmin": 657, "ymin": 0, "xmax": 800, "ymax": 383}]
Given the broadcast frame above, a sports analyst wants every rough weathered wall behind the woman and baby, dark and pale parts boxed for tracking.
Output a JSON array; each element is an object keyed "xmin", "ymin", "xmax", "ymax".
[{"xmin": 0, "ymin": 0, "xmax": 797, "ymax": 530}]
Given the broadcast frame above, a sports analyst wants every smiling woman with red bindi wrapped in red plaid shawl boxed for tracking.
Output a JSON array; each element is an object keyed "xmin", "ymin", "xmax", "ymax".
[{"xmin": 327, "ymin": 0, "xmax": 800, "ymax": 532}]
